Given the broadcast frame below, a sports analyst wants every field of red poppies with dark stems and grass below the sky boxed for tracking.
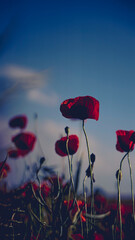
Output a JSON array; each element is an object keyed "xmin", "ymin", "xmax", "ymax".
[{"xmin": 0, "ymin": 96, "xmax": 135, "ymax": 240}]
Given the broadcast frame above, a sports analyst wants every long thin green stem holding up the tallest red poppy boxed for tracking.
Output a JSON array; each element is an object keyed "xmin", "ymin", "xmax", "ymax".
[{"xmin": 82, "ymin": 120, "xmax": 94, "ymax": 215}]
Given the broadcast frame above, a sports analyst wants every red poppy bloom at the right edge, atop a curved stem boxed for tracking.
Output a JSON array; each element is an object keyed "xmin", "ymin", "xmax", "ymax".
[{"xmin": 116, "ymin": 130, "xmax": 134, "ymax": 152}]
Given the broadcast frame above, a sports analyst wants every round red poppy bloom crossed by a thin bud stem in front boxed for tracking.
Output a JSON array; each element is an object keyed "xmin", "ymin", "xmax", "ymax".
[{"xmin": 55, "ymin": 135, "xmax": 79, "ymax": 157}]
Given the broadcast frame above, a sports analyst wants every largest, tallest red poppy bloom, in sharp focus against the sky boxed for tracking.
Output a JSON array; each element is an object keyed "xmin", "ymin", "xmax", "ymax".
[{"xmin": 60, "ymin": 96, "xmax": 99, "ymax": 120}]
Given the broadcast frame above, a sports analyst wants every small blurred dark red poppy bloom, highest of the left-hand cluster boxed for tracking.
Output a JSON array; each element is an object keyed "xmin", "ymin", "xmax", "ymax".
[{"xmin": 9, "ymin": 115, "xmax": 28, "ymax": 129}]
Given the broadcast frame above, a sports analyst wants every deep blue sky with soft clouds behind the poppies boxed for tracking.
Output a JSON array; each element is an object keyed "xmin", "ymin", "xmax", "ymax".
[{"xmin": 0, "ymin": 0, "xmax": 135, "ymax": 193}]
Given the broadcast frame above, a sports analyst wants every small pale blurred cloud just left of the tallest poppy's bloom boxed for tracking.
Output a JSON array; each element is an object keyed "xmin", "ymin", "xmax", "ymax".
[{"xmin": 28, "ymin": 89, "xmax": 58, "ymax": 106}]
